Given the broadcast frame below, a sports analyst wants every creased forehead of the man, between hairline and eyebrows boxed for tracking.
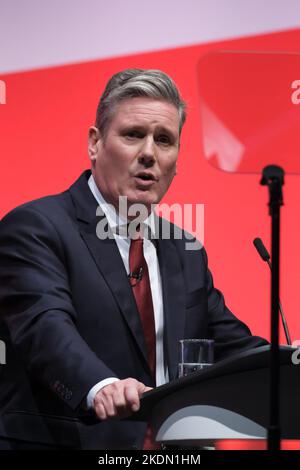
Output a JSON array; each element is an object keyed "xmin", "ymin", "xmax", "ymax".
[{"xmin": 111, "ymin": 97, "xmax": 179, "ymax": 132}]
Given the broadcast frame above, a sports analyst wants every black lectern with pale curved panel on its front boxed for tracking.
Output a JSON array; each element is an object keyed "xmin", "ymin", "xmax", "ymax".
[{"xmin": 134, "ymin": 346, "xmax": 300, "ymax": 446}]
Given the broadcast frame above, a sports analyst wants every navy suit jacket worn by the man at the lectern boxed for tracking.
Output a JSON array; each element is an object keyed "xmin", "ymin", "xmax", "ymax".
[{"xmin": 0, "ymin": 171, "xmax": 265, "ymax": 449}]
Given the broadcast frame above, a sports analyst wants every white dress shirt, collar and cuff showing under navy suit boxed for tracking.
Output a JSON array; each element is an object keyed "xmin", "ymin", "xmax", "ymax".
[{"xmin": 87, "ymin": 175, "xmax": 169, "ymax": 408}]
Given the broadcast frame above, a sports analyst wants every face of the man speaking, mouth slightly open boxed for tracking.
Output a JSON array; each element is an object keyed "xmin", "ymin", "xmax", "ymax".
[{"xmin": 89, "ymin": 97, "xmax": 179, "ymax": 215}]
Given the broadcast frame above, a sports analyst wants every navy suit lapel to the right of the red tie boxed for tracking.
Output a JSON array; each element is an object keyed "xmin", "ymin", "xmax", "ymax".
[{"xmin": 157, "ymin": 235, "xmax": 185, "ymax": 380}]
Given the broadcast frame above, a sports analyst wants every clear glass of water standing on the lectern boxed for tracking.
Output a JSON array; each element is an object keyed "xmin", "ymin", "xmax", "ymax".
[{"xmin": 178, "ymin": 339, "xmax": 214, "ymax": 377}]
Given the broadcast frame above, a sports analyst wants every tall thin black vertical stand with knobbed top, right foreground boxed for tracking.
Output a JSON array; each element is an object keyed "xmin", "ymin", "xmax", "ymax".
[{"xmin": 260, "ymin": 165, "xmax": 284, "ymax": 450}]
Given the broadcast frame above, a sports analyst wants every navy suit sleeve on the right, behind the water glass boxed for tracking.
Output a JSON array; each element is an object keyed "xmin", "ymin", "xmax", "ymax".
[{"xmin": 201, "ymin": 248, "xmax": 268, "ymax": 360}]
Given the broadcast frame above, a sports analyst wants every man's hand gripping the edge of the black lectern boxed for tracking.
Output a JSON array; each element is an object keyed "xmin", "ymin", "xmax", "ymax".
[{"xmin": 94, "ymin": 378, "xmax": 151, "ymax": 420}]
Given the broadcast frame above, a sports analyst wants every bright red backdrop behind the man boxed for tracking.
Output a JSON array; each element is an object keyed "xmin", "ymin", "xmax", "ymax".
[{"xmin": 0, "ymin": 30, "xmax": 300, "ymax": 346}]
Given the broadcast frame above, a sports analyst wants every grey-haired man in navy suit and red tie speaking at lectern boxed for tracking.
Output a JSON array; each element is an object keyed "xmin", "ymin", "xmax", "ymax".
[{"xmin": 0, "ymin": 69, "xmax": 264, "ymax": 449}]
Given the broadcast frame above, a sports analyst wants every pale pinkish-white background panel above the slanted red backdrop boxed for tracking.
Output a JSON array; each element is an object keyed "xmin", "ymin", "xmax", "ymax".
[{"xmin": 0, "ymin": 0, "xmax": 300, "ymax": 73}]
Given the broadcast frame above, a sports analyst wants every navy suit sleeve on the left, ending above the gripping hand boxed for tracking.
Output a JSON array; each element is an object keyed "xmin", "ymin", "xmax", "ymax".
[{"xmin": 0, "ymin": 206, "xmax": 116, "ymax": 410}]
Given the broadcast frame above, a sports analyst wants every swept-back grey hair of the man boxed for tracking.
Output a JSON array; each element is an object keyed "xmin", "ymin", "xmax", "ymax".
[{"xmin": 95, "ymin": 69, "xmax": 186, "ymax": 136}]
